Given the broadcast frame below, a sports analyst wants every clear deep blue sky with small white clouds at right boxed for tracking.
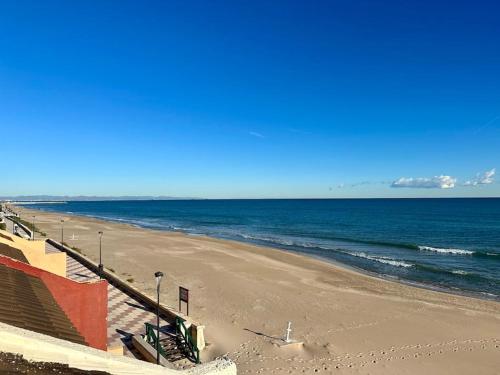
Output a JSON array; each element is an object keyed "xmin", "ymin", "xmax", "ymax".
[{"xmin": 0, "ymin": 1, "xmax": 500, "ymax": 198}]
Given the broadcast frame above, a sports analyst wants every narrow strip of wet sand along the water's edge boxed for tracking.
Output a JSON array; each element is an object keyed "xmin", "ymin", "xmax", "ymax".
[{"xmin": 17, "ymin": 204, "xmax": 500, "ymax": 302}]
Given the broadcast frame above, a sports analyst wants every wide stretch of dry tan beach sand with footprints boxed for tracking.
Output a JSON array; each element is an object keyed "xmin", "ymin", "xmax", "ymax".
[{"xmin": 11, "ymin": 208, "xmax": 500, "ymax": 375}]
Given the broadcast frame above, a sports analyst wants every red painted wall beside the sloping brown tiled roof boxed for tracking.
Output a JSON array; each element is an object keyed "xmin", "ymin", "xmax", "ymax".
[{"xmin": 0, "ymin": 255, "xmax": 108, "ymax": 350}]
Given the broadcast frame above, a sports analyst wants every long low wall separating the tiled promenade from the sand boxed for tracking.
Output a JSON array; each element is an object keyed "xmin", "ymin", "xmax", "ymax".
[{"xmin": 47, "ymin": 238, "xmax": 205, "ymax": 350}]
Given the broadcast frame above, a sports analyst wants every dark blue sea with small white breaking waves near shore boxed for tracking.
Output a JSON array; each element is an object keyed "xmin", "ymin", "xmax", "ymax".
[{"xmin": 23, "ymin": 198, "xmax": 500, "ymax": 299}]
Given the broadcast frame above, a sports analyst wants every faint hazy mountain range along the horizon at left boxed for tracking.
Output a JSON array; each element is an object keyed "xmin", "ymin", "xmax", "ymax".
[{"xmin": 0, "ymin": 195, "xmax": 200, "ymax": 202}]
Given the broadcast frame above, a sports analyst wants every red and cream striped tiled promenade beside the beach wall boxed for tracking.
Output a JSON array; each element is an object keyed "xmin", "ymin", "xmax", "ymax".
[{"xmin": 46, "ymin": 244, "xmax": 168, "ymax": 356}]
